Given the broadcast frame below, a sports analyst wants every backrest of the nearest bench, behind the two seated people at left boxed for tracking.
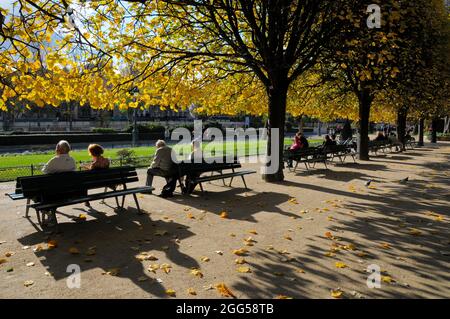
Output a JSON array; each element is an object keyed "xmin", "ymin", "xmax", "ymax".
[{"xmin": 20, "ymin": 167, "xmax": 139, "ymax": 199}]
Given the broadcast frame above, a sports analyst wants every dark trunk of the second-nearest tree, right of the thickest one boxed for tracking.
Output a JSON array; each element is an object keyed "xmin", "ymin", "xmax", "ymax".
[{"xmin": 358, "ymin": 90, "xmax": 373, "ymax": 161}]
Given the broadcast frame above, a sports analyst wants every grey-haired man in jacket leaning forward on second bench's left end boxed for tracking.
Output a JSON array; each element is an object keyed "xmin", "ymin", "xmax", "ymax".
[{"xmin": 145, "ymin": 140, "xmax": 176, "ymax": 197}]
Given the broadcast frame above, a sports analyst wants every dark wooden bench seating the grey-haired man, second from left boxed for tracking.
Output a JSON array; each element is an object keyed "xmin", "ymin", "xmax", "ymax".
[{"xmin": 178, "ymin": 157, "xmax": 256, "ymax": 192}]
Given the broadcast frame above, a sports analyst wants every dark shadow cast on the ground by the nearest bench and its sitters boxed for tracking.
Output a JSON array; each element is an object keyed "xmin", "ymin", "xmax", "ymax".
[{"xmin": 18, "ymin": 207, "xmax": 198, "ymax": 297}]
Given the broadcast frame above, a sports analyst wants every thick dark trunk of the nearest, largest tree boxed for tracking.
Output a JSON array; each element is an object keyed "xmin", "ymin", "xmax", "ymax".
[{"xmin": 263, "ymin": 84, "xmax": 288, "ymax": 182}]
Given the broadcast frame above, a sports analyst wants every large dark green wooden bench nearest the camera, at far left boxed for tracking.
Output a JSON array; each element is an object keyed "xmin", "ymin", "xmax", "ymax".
[{"xmin": 7, "ymin": 167, "xmax": 153, "ymax": 227}]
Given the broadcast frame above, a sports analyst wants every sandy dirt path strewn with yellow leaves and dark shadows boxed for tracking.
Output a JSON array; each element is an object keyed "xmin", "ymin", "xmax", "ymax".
[{"xmin": 0, "ymin": 143, "xmax": 450, "ymax": 298}]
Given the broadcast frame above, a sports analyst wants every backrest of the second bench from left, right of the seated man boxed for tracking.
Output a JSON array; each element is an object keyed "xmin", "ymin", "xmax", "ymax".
[{"xmin": 178, "ymin": 157, "xmax": 241, "ymax": 176}]
